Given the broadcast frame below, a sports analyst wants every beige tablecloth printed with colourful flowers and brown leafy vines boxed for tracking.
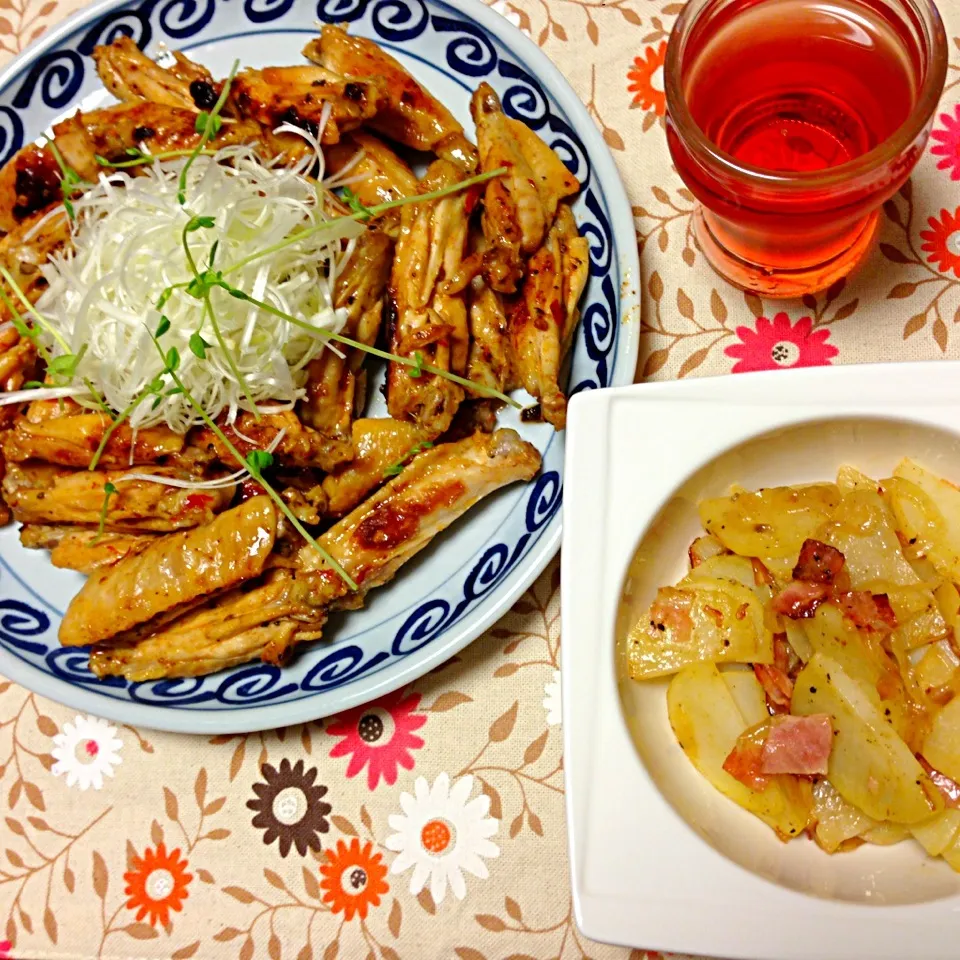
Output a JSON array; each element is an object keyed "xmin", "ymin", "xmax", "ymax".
[{"xmin": 0, "ymin": 0, "xmax": 960, "ymax": 960}]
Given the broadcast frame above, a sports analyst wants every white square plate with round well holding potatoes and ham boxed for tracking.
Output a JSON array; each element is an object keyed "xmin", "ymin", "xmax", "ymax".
[{"xmin": 562, "ymin": 362, "xmax": 960, "ymax": 960}]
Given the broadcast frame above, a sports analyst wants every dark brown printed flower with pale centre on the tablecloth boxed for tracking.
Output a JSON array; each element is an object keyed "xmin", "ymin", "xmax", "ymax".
[{"xmin": 247, "ymin": 759, "xmax": 332, "ymax": 857}]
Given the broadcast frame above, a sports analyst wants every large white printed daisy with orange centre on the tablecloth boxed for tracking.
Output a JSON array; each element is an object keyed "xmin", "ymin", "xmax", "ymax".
[{"xmin": 386, "ymin": 773, "xmax": 500, "ymax": 903}]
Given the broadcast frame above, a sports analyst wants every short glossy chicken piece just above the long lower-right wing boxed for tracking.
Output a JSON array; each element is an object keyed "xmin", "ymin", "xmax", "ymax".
[{"xmin": 323, "ymin": 417, "xmax": 427, "ymax": 517}]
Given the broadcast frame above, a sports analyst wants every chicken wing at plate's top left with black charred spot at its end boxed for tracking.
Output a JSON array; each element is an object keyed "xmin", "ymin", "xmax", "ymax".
[{"xmin": 93, "ymin": 36, "xmax": 212, "ymax": 110}]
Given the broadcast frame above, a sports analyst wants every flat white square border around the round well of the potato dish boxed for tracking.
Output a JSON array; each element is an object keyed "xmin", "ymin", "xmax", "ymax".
[{"xmin": 561, "ymin": 361, "xmax": 960, "ymax": 960}]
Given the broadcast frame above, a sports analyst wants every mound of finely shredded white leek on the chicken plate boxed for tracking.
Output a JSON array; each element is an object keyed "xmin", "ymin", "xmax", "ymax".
[{"xmin": 37, "ymin": 137, "xmax": 365, "ymax": 433}]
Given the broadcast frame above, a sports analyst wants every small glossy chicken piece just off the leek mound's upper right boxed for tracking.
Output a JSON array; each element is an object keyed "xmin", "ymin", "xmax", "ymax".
[{"xmin": 324, "ymin": 130, "xmax": 418, "ymax": 239}]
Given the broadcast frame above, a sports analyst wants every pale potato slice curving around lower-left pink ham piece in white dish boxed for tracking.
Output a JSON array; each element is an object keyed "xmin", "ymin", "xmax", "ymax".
[{"xmin": 667, "ymin": 663, "xmax": 813, "ymax": 839}]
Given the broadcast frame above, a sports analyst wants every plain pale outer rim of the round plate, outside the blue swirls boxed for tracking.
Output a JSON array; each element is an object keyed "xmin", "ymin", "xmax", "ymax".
[{"xmin": 0, "ymin": 0, "xmax": 642, "ymax": 736}]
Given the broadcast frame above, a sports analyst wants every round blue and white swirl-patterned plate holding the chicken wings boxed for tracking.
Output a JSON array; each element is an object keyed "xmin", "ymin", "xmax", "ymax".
[{"xmin": 0, "ymin": 0, "xmax": 640, "ymax": 734}]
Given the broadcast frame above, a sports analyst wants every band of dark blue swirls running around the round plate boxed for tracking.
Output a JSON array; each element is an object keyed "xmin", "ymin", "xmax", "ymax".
[{"xmin": 0, "ymin": 0, "xmax": 632, "ymax": 725}]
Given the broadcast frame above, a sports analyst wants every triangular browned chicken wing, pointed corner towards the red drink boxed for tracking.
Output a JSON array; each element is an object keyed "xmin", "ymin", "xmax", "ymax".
[{"xmin": 470, "ymin": 83, "xmax": 580, "ymax": 293}]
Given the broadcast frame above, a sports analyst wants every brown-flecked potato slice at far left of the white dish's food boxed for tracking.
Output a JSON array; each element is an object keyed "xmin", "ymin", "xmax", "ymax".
[{"xmin": 627, "ymin": 572, "xmax": 773, "ymax": 680}]
